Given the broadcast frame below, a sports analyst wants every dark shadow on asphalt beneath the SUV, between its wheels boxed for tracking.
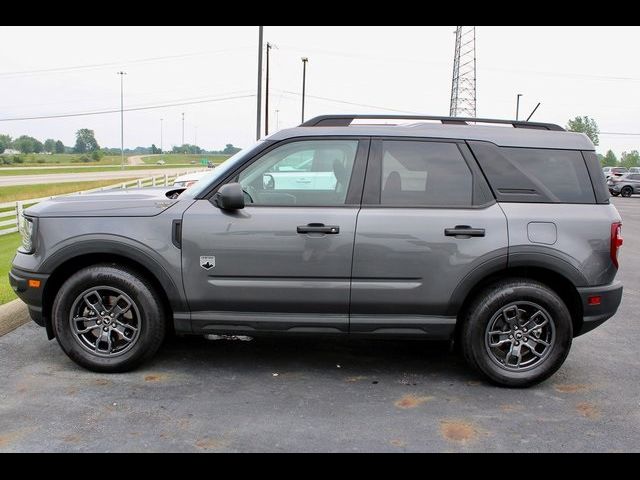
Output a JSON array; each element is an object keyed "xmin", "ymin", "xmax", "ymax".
[{"xmin": 153, "ymin": 336, "xmax": 481, "ymax": 381}]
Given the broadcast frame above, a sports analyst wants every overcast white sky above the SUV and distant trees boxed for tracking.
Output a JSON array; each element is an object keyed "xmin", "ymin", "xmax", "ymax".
[{"xmin": 0, "ymin": 26, "xmax": 640, "ymax": 155}]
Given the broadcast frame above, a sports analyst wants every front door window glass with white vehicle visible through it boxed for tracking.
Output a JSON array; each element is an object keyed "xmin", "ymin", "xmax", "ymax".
[{"xmin": 236, "ymin": 140, "xmax": 358, "ymax": 206}]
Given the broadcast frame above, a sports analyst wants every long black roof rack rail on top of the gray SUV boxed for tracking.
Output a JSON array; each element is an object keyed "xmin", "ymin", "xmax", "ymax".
[{"xmin": 299, "ymin": 115, "xmax": 565, "ymax": 131}]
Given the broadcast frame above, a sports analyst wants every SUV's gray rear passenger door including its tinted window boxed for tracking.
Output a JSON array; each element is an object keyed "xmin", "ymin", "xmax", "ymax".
[{"xmin": 350, "ymin": 138, "xmax": 507, "ymax": 337}]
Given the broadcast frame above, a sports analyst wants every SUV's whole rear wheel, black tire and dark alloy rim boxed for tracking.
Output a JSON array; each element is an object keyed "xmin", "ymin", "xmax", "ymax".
[{"xmin": 461, "ymin": 278, "xmax": 573, "ymax": 387}]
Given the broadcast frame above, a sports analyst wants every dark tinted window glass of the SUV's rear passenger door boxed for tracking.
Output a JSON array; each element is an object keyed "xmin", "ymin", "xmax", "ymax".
[{"xmin": 380, "ymin": 140, "xmax": 473, "ymax": 206}]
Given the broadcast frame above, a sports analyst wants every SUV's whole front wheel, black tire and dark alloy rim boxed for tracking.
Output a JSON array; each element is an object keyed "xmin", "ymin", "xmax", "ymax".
[{"xmin": 51, "ymin": 264, "xmax": 166, "ymax": 372}]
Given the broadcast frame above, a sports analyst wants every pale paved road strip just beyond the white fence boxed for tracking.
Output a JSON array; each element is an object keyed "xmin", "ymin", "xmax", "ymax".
[{"xmin": 0, "ymin": 166, "xmax": 197, "ymax": 187}]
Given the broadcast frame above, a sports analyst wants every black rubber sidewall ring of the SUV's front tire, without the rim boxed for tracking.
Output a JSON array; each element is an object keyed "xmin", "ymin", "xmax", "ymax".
[{"xmin": 51, "ymin": 266, "xmax": 164, "ymax": 372}]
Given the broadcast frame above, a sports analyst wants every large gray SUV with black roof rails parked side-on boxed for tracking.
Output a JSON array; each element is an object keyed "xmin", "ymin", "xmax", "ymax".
[{"xmin": 10, "ymin": 115, "xmax": 622, "ymax": 386}]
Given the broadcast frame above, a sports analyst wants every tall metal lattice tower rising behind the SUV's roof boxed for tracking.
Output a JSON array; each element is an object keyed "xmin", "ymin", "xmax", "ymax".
[{"xmin": 449, "ymin": 27, "xmax": 476, "ymax": 117}]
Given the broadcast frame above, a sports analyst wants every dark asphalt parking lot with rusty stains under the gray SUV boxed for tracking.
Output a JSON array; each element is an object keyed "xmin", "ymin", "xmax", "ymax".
[{"xmin": 0, "ymin": 197, "xmax": 640, "ymax": 452}]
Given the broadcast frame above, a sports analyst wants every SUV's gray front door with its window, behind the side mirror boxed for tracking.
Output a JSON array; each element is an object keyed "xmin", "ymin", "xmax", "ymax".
[{"xmin": 182, "ymin": 138, "xmax": 368, "ymax": 334}]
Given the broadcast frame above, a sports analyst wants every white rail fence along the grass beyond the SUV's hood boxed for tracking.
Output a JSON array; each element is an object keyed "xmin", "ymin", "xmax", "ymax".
[{"xmin": 0, "ymin": 170, "xmax": 199, "ymax": 236}]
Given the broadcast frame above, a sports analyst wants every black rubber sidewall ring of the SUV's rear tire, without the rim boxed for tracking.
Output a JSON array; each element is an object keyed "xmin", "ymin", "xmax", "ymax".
[{"xmin": 465, "ymin": 282, "xmax": 573, "ymax": 387}]
